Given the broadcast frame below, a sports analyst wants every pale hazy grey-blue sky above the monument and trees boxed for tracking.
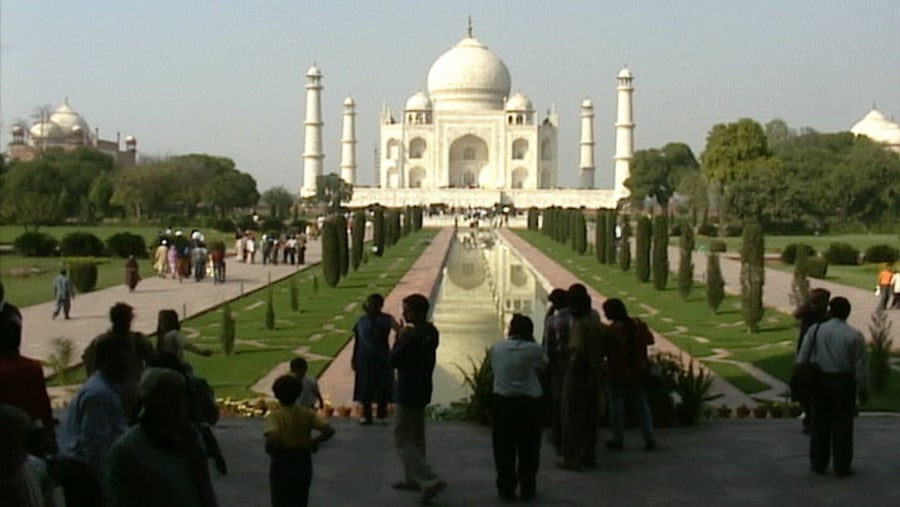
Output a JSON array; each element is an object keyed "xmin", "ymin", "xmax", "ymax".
[{"xmin": 0, "ymin": 0, "xmax": 900, "ymax": 191}]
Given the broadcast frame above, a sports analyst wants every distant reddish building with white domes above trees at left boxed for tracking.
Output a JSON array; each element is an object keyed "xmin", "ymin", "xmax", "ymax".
[{"xmin": 7, "ymin": 100, "xmax": 137, "ymax": 166}]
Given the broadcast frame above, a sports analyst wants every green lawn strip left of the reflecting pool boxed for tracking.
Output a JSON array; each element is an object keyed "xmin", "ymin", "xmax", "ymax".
[{"xmin": 182, "ymin": 229, "xmax": 437, "ymax": 398}]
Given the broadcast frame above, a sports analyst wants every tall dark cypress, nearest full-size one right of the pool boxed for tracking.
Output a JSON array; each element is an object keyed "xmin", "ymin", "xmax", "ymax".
[{"xmin": 741, "ymin": 221, "xmax": 766, "ymax": 333}]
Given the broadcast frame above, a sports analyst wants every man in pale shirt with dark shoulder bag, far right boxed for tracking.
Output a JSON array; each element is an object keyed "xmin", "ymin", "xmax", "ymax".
[{"xmin": 796, "ymin": 297, "xmax": 869, "ymax": 477}]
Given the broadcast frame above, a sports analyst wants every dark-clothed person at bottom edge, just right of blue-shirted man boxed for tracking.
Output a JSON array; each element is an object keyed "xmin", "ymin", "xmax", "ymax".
[{"xmin": 106, "ymin": 368, "xmax": 218, "ymax": 507}]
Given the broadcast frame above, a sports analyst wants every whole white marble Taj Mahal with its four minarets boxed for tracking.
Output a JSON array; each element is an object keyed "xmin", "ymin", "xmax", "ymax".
[{"xmin": 300, "ymin": 25, "xmax": 635, "ymax": 208}]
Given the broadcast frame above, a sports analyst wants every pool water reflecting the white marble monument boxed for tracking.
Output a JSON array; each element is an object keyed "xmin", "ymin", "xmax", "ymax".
[{"xmin": 432, "ymin": 229, "xmax": 547, "ymax": 405}]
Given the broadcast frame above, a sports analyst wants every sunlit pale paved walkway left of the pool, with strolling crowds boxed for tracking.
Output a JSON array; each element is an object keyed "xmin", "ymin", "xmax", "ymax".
[{"xmin": 15, "ymin": 241, "xmax": 321, "ymax": 370}]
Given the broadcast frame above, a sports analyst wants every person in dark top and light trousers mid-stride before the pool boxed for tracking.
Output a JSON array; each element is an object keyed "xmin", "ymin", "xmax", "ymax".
[{"xmin": 391, "ymin": 294, "xmax": 447, "ymax": 503}]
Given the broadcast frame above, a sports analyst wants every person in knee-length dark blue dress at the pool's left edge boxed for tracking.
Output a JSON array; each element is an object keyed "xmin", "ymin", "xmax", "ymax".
[{"xmin": 350, "ymin": 294, "xmax": 399, "ymax": 425}]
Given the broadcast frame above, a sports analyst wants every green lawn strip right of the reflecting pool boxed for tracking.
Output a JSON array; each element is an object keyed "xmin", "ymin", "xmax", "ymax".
[{"xmin": 517, "ymin": 230, "xmax": 900, "ymax": 410}]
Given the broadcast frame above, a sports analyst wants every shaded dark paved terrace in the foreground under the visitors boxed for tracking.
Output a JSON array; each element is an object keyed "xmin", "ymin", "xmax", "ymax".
[{"xmin": 207, "ymin": 417, "xmax": 900, "ymax": 507}]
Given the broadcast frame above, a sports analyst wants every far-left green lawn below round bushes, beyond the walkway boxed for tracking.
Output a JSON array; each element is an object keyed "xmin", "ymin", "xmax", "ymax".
[{"xmin": 0, "ymin": 253, "xmax": 155, "ymax": 307}]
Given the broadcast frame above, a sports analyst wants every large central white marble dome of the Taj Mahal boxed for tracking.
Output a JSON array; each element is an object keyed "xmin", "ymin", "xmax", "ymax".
[{"xmin": 428, "ymin": 36, "xmax": 510, "ymax": 110}]
